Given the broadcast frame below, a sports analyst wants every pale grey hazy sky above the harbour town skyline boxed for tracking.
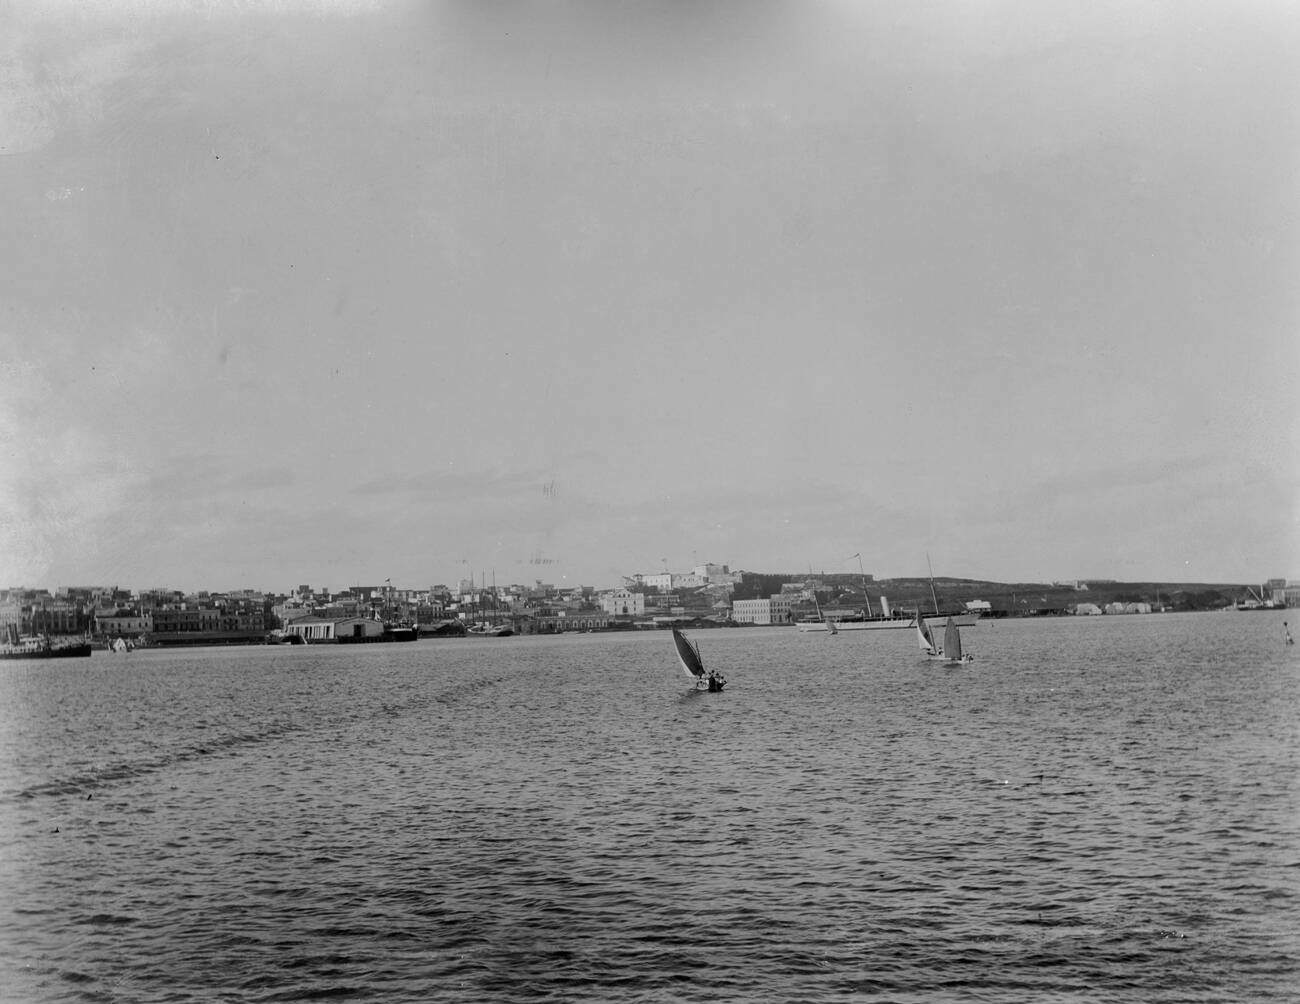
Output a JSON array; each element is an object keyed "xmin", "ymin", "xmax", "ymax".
[{"xmin": 0, "ymin": 0, "xmax": 1300, "ymax": 590}]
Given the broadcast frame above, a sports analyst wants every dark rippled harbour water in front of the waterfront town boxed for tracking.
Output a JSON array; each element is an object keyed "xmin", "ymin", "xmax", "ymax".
[{"xmin": 0, "ymin": 613, "xmax": 1300, "ymax": 1001}]
